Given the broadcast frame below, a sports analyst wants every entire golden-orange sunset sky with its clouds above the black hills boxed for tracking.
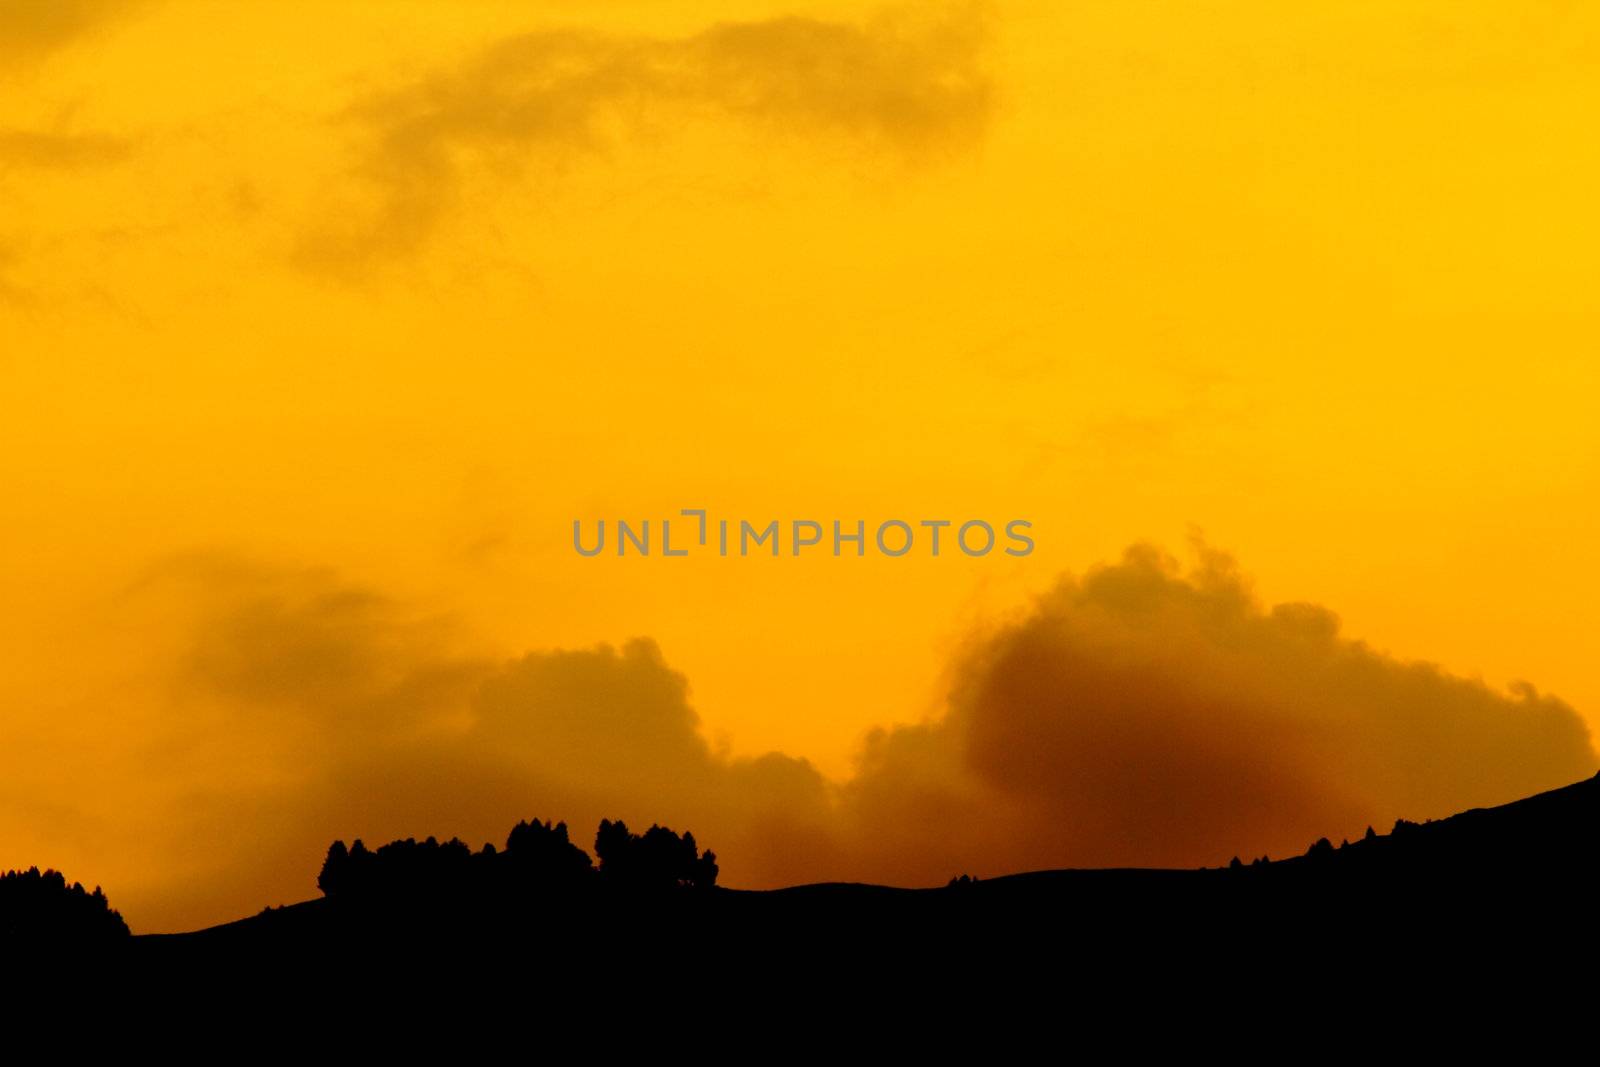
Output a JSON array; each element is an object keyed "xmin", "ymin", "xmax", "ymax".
[{"xmin": 0, "ymin": 0, "xmax": 1600, "ymax": 933}]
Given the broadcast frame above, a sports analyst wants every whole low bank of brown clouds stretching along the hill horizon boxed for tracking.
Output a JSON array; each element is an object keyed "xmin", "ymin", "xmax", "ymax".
[{"xmin": 9, "ymin": 547, "xmax": 1597, "ymax": 929}]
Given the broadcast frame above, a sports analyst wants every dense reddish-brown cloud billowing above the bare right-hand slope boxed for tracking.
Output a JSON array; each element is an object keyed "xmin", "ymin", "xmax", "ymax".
[{"xmin": 846, "ymin": 547, "xmax": 1595, "ymax": 881}]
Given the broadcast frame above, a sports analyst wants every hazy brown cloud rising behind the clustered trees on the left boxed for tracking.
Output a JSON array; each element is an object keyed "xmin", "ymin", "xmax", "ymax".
[{"xmin": 104, "ymin": 555, "xmax": 832, "ymax": 929}]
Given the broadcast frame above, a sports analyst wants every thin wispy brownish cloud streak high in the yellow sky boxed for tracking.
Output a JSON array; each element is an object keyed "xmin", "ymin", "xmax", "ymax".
[{"xmin": 296, "ymin": 8, "xmax": 994, "ymax": 270}]
